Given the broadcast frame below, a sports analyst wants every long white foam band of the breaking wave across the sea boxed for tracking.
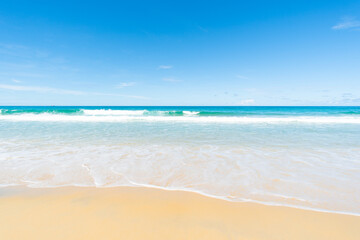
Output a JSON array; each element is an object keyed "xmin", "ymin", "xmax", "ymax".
[{"xmin": 0, "ymin": 113, "xmax": 360, "ymax": 124}]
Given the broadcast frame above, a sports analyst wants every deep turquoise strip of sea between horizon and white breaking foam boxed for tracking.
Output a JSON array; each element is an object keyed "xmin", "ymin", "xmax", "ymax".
[{"xmin": 0, "ymin": 106, "xmax": 360, "ymax": 116}]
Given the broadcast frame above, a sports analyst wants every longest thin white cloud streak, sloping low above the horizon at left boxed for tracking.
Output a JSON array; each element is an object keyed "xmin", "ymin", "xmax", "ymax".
[{"xmin": 0, "ymin": 84, "xmax": 150, "ymax": 99}]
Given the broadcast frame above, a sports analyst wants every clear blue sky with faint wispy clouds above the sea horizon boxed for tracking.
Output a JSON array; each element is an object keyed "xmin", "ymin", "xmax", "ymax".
[{"xmin": 0, "ymin": 0, "xmax": 360, "ymax": 106}]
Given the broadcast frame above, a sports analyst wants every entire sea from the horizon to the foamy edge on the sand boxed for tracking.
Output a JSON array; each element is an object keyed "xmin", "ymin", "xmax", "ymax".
[{"xmin": 0, "ymin": 106, "xmax": 360, "ymax": 214}]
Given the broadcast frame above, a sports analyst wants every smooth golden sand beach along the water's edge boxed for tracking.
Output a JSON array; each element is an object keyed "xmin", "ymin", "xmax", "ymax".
[{"xmin": 0, "ymin": 187, "xmax": 360, "ymax": 240}]
